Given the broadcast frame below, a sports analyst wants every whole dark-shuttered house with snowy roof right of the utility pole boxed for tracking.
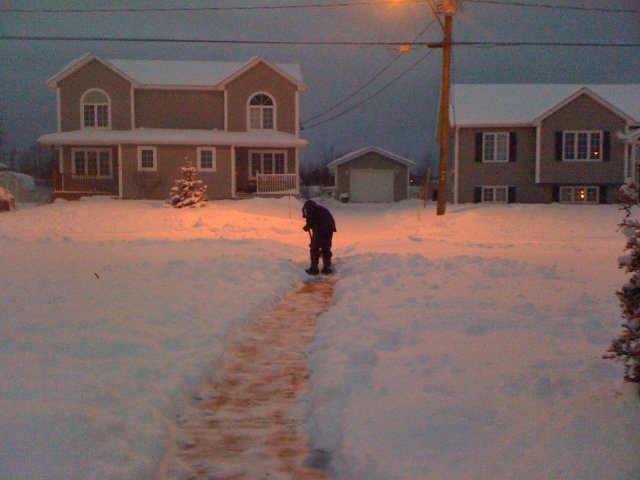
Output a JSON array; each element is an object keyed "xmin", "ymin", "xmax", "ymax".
[{"xmin": 451, "ymin": 84, "xmax": 640, "ymax": 203}]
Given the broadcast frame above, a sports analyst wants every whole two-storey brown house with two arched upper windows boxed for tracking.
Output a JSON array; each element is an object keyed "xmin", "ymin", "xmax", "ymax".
[{"xmin": 38, "ymin": 54, "xmax": 307, "ymax": 199}]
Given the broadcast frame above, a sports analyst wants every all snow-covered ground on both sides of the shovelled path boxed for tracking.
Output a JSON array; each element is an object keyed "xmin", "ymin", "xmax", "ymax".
[{"xmin": 0, "ymin": 198, "xmax": 640, "ymax": 480}]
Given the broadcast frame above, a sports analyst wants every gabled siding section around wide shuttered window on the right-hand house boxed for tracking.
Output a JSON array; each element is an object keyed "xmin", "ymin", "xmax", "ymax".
[{"xmin": 540, "ymin": 95, "xmax": 626, "ymax": 185}]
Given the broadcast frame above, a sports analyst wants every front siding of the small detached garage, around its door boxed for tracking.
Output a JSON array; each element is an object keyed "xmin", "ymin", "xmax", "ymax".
[{"xmin": 335, "ymin": 152, "xmax": 409, "ymax": 202}]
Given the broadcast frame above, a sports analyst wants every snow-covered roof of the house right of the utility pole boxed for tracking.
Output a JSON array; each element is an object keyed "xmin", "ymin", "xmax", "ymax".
[{"xmin": 450, "ymin": 84, "xmax": 640, "ymax": 126}]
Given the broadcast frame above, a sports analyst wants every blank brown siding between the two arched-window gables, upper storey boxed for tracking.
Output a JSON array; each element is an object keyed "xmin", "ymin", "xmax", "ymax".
[{"xmin": 134, "ymin": 89, "xmax": 224, "ymax": 130}]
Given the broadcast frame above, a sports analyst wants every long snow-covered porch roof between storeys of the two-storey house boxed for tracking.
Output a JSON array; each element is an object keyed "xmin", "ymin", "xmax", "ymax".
[{"xmin": 38, "ymin": 128, "xmax": 308, "ymax": 148}]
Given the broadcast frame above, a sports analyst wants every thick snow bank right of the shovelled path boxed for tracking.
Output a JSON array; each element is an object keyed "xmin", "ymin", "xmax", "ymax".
[{"xmin": 310, "ymin": 254, "xmax": 640, "ymax": 480}]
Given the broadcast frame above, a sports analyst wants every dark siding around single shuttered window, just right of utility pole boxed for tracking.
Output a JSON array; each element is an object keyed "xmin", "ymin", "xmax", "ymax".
[{"xmin": 458, "ymin": 127, "xmax": 551, "ymax": 203}]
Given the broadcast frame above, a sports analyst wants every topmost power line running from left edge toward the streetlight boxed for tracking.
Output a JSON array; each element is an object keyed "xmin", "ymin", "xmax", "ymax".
[{"xmin": 0, "ymin": 0, "xmax": 426, "ymax": 13}]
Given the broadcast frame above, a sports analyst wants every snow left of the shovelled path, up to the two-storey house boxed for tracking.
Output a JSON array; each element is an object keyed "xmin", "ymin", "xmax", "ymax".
[{"xmin": 0, "ymin": 200, "xmax": 302, "ymax": 479}]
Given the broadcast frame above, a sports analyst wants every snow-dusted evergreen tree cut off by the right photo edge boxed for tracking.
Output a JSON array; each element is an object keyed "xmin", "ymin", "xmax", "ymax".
[{"xmin": 604, "ymin": 184, "xmax": 640, "ymax": 392}]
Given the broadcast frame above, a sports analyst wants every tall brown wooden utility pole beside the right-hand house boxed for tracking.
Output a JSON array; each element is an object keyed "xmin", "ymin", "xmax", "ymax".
[{"xmin": 434, "ymin": 0, "xmax": 458, "ymax": 215}]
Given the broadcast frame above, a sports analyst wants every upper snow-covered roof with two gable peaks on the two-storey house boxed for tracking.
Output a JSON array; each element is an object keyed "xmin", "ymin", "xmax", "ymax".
[{"xmin": 47, "ymin": 53, "xmax": 307, "ymax": 91}]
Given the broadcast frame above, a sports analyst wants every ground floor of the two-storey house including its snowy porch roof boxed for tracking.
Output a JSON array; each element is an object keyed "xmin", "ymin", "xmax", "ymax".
[{"xmin": 38, "ymin": 128, "xmax": 307, "ymax": 199}]
